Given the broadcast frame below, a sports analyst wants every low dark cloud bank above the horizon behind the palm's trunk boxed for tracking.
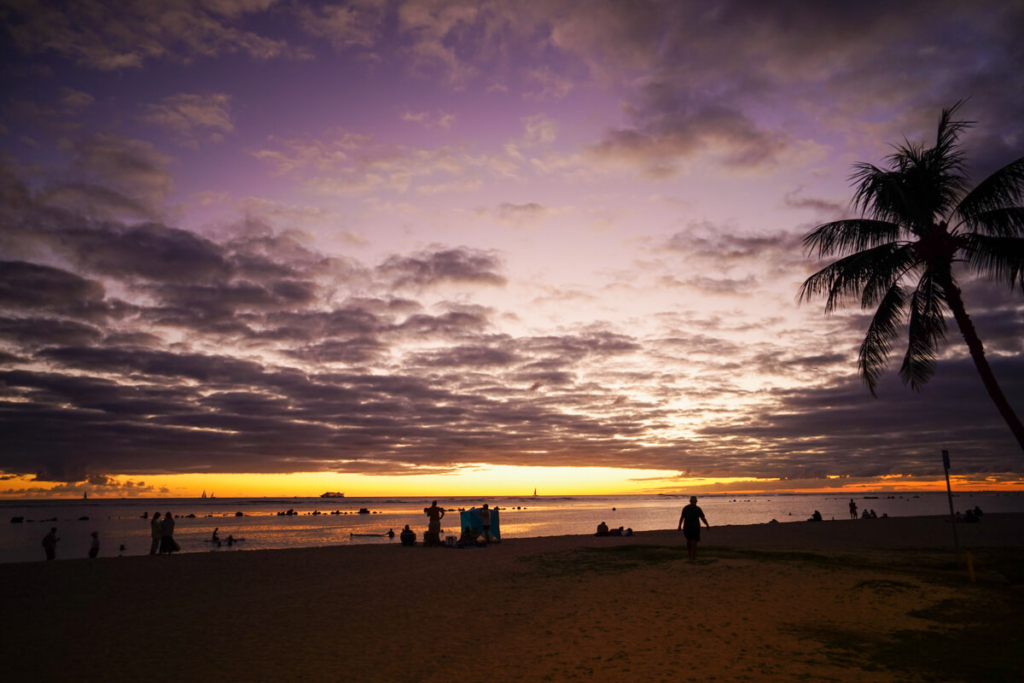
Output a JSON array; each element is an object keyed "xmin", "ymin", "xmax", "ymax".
[{"xmin": 701, "ymin": 358, "xmax": 1024, "ymax": 477}]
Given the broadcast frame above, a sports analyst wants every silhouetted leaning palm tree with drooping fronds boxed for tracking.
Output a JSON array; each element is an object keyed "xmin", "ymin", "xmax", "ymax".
[{"xmin": 800, "ymin": 100, "xmax": 1024, "ymax": 450}]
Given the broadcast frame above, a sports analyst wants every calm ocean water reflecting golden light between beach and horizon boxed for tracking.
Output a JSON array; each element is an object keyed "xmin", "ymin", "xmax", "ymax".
[{"xmin": 0, "ymin": 493, "xmax": 1024, "ymax": 562}]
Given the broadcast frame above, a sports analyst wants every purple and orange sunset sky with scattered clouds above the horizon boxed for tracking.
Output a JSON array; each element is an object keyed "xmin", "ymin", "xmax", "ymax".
[{"xmin": 0, "ymin": 0, "xmax": 1024, "ymax": 497}]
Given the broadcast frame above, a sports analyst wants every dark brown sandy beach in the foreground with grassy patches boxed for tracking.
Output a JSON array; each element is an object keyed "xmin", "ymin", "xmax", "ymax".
[{"xmin": 0, "ymin": 514, "xmax": 1024, "ymax": 683}]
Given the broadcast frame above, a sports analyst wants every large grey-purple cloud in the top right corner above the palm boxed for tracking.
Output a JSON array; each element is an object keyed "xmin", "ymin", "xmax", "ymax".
[{"xmin": 577, "ymin": 0, "xmax": 1024, "ymax": 177}]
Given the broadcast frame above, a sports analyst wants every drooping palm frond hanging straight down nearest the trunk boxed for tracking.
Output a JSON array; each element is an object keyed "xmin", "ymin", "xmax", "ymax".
[{"xmin": 899, "ymin": 271, "xmax": 946, "ymax": 391}]
